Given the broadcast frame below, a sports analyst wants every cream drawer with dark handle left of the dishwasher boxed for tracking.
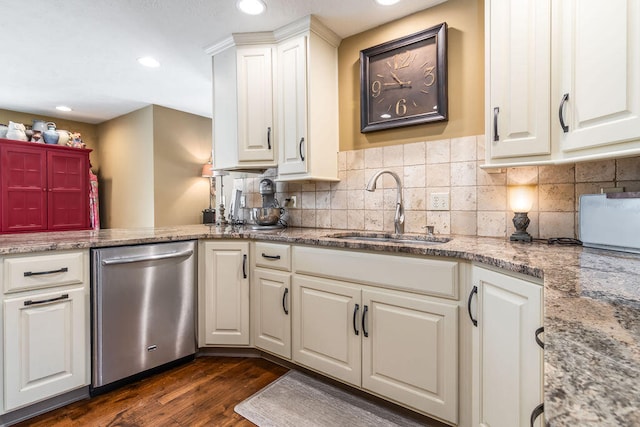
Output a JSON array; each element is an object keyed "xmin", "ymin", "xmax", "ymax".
[{"xmin": 3, "ymin": 251, "xmax": 88, "ymax": 293}]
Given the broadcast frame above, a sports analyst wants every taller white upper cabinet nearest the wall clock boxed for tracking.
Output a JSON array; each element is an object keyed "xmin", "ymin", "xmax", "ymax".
[{"xmin": 276, "ymin": 16, "xmax": 340, "ymax": 181}]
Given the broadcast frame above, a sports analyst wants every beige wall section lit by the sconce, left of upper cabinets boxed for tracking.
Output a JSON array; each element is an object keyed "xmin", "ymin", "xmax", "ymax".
[{"xmin": 153, "ymin": 105, "xmax": 212, "ymax": 227}]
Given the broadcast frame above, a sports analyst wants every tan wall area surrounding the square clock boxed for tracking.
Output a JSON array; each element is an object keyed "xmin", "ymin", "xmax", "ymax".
[{"xmin": 338, "ymin": 0, "xmax": 484, "ymax": 151}]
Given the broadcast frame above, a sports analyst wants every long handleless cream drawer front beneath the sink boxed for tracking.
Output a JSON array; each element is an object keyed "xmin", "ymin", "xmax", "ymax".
[{"xmin": 293, "ymin": 246, "xmax": 458, "ymax": 299}]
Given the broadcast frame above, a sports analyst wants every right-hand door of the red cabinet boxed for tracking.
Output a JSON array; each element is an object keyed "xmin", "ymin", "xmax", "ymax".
[{"xmin": 47, "ymin": 151, "xmax": 89, "ymax": 231}]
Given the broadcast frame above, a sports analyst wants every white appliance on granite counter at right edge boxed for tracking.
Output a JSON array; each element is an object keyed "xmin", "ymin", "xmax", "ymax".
[{"xmin": 579, "ymin": 193, "xmax": 640, "ymax": 253}]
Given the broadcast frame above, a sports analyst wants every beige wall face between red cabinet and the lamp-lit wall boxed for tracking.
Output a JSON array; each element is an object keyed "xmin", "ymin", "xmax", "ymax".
[{"xmin": 98, "ymin": 106, "xmax": 154, "ymax": 228}]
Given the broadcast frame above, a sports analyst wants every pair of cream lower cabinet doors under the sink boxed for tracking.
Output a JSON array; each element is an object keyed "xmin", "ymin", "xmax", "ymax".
[{"xmin": 293, "ymin": 275, "xmax": 458, "ymax": 423}]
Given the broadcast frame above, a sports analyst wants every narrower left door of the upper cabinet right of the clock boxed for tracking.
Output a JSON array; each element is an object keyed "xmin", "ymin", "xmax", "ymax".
[{"xmin": 485, "ymin": 0, "xmax": 551, "ymax": 159}]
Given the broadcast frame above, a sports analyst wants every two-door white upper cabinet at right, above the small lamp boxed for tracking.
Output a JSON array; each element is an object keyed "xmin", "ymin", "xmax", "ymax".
[{"xmin": 485, "ymin": 0, "xmax": 640, "ymax": 166}]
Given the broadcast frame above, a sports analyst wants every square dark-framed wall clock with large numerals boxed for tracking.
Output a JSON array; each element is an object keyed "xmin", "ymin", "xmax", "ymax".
[{"xmin": 360, "ymin": 22, "xmax": 447, "ymax": 133}]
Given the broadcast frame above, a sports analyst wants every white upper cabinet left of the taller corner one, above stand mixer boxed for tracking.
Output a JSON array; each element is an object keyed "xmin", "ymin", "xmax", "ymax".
[{"xmin": 209, "ymin": 34, "xmax": 277, "ymax": 170}]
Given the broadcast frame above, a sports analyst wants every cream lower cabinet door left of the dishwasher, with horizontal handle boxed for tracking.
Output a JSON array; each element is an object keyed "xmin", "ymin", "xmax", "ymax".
[{"xmin": 4, "ymin": 288, "xmax": 89, "ymax": 411}]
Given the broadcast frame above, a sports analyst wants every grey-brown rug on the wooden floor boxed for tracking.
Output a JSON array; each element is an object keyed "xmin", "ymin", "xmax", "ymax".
[{"xmin": 234, "ymin": 371, "xmax": 432, "ymax": 427}]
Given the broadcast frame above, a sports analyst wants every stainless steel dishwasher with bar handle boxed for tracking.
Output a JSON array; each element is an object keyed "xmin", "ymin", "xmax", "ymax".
[{"xmin": 91, "ymin": 241, "xmax": 196, "ymax": 394}]
